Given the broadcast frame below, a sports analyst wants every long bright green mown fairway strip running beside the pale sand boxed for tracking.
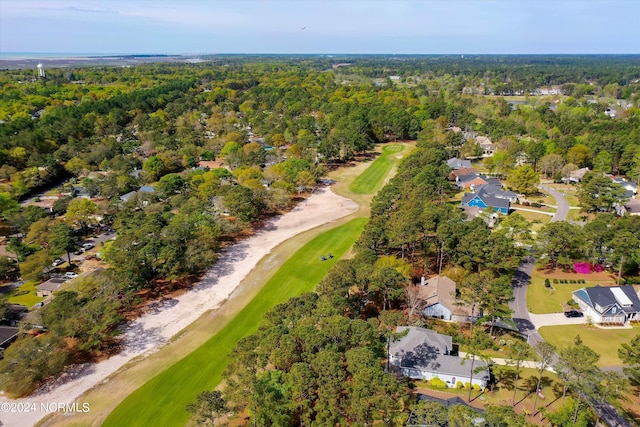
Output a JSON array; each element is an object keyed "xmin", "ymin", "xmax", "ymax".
[{"xmin": 103, "ymin": 218, "xmax": 367, "ymax": 427}]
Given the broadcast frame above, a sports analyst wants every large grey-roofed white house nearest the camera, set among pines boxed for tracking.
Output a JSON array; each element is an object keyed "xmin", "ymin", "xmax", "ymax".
[{"xmin": 388, "ymin": 326, "xmax": 490, "ymax": 389}]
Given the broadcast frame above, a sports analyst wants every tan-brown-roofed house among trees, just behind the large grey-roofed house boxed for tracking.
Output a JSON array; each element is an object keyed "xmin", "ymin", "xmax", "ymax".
[{"xmin": 418, "ymin": 275, "xmax": 478, "ymax": 322}]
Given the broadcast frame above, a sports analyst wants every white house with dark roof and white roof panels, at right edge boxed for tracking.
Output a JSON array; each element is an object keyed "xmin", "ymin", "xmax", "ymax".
[{"xmin": 573, "ymin": 286, "xmax": 640, "ymax": 325}]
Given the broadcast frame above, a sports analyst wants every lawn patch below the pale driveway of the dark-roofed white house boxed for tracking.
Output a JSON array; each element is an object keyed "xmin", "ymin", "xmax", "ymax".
[{"xmin": 538, "ymin": 325, "xmax": 640, "ymax": 366}]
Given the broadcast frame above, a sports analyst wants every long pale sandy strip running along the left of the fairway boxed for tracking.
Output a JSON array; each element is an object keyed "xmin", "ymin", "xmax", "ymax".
[{"xmin": 0, "ymin": 187, "xmax": 358, "ymax": 427}]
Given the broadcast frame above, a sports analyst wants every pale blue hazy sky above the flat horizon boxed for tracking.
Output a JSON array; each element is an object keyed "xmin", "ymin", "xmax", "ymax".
[{"xmin": 0, "ymin": 0, "xmax": 640, "ymax": 55}]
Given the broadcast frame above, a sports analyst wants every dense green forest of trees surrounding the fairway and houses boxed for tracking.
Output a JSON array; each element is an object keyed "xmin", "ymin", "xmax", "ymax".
[{"xmin": 0, "ymin": 56, "xmax": 640, "ymax": 426}]
